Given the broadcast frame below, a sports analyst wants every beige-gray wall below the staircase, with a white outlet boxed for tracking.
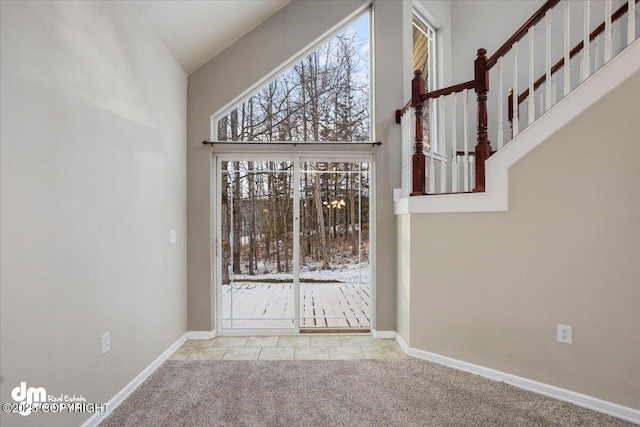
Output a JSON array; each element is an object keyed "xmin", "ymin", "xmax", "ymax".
[{"xmin": 400, "ymin": 73, "xmax": 640, "ymax": 409}]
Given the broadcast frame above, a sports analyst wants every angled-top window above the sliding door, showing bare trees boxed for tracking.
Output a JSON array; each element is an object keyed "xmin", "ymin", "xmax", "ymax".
[{"xmin": 217, "ymin": 12, "xmax": 371, "ymax": 142}]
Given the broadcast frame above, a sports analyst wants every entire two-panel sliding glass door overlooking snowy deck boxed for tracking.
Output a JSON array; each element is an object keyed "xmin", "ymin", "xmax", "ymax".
[{"xmin": 216, "ymin": 156, "xmax": 371, "ymax": 334}]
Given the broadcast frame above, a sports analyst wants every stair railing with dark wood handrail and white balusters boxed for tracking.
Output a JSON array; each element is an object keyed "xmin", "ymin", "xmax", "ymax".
[{"xmin": 396, "ymin": 0, "xmax": 640, "ymax": 196}]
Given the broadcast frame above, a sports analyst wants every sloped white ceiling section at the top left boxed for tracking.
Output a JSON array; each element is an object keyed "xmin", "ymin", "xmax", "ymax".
[{"xmin": 130, "ymin": 0, "xmax": 291, "ymax": 74}]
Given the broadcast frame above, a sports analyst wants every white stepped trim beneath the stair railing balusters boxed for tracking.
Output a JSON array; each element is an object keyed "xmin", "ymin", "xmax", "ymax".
[{"xmin": 394, "ymin": 39, "xmax": 640, "ymax": 215}]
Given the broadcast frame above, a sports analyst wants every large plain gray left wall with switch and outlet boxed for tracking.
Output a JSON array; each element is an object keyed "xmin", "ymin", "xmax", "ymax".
[{"xmin": 0, "ymin": 2, "xmax": 187, "ymax": 426}]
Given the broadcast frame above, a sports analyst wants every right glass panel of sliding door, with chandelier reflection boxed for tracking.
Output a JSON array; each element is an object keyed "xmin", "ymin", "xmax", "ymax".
[{"xmin": 299, "ymin": 161, "xmax": 371, "ymax": 329}]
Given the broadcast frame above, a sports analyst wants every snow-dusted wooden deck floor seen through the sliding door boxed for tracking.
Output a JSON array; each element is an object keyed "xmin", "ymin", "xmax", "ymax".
[{"xmin": 222, "ymin": 282, "xmax": 371, "ymax": 329}]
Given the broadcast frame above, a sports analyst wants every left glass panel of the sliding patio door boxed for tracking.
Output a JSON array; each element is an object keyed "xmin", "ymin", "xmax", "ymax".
[{"xmin": 219, "ymin": 160, "xmax": 297, "ymax": 330}]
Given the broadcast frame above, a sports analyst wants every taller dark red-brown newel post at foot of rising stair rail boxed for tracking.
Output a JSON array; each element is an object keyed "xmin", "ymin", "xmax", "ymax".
[{"xmin": 473, "ymin": 48, "xmax": 491, "ymax": 193}]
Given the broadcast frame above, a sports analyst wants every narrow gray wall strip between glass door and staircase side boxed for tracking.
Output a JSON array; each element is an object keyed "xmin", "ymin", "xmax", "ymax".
[{"xmin": 373, "ymin": 0, "xmax": 404, "ymax": 331}]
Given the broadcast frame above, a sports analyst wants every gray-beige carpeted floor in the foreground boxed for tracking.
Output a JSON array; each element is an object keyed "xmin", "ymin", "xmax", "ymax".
[{"xmin": 101, "ymin": 359, "xmax": 632, "ymax": 427}]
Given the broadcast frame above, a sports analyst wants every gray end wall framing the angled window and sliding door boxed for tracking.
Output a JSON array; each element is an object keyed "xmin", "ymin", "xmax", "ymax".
[{"xmin": 187, "ymin": 0, "xmax": 410, "ymax": 330}]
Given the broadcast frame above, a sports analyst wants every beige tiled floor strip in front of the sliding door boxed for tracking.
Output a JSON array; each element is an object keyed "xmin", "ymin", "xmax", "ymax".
[{"xmin": 169, "ymin": 335, "xmax": 408, "ymax": 360}]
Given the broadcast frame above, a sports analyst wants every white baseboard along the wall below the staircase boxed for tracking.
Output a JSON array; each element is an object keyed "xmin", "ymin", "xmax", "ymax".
[{"xmin": 396, "ymin": 334, "xmax": 640, "ymax": 424}]
